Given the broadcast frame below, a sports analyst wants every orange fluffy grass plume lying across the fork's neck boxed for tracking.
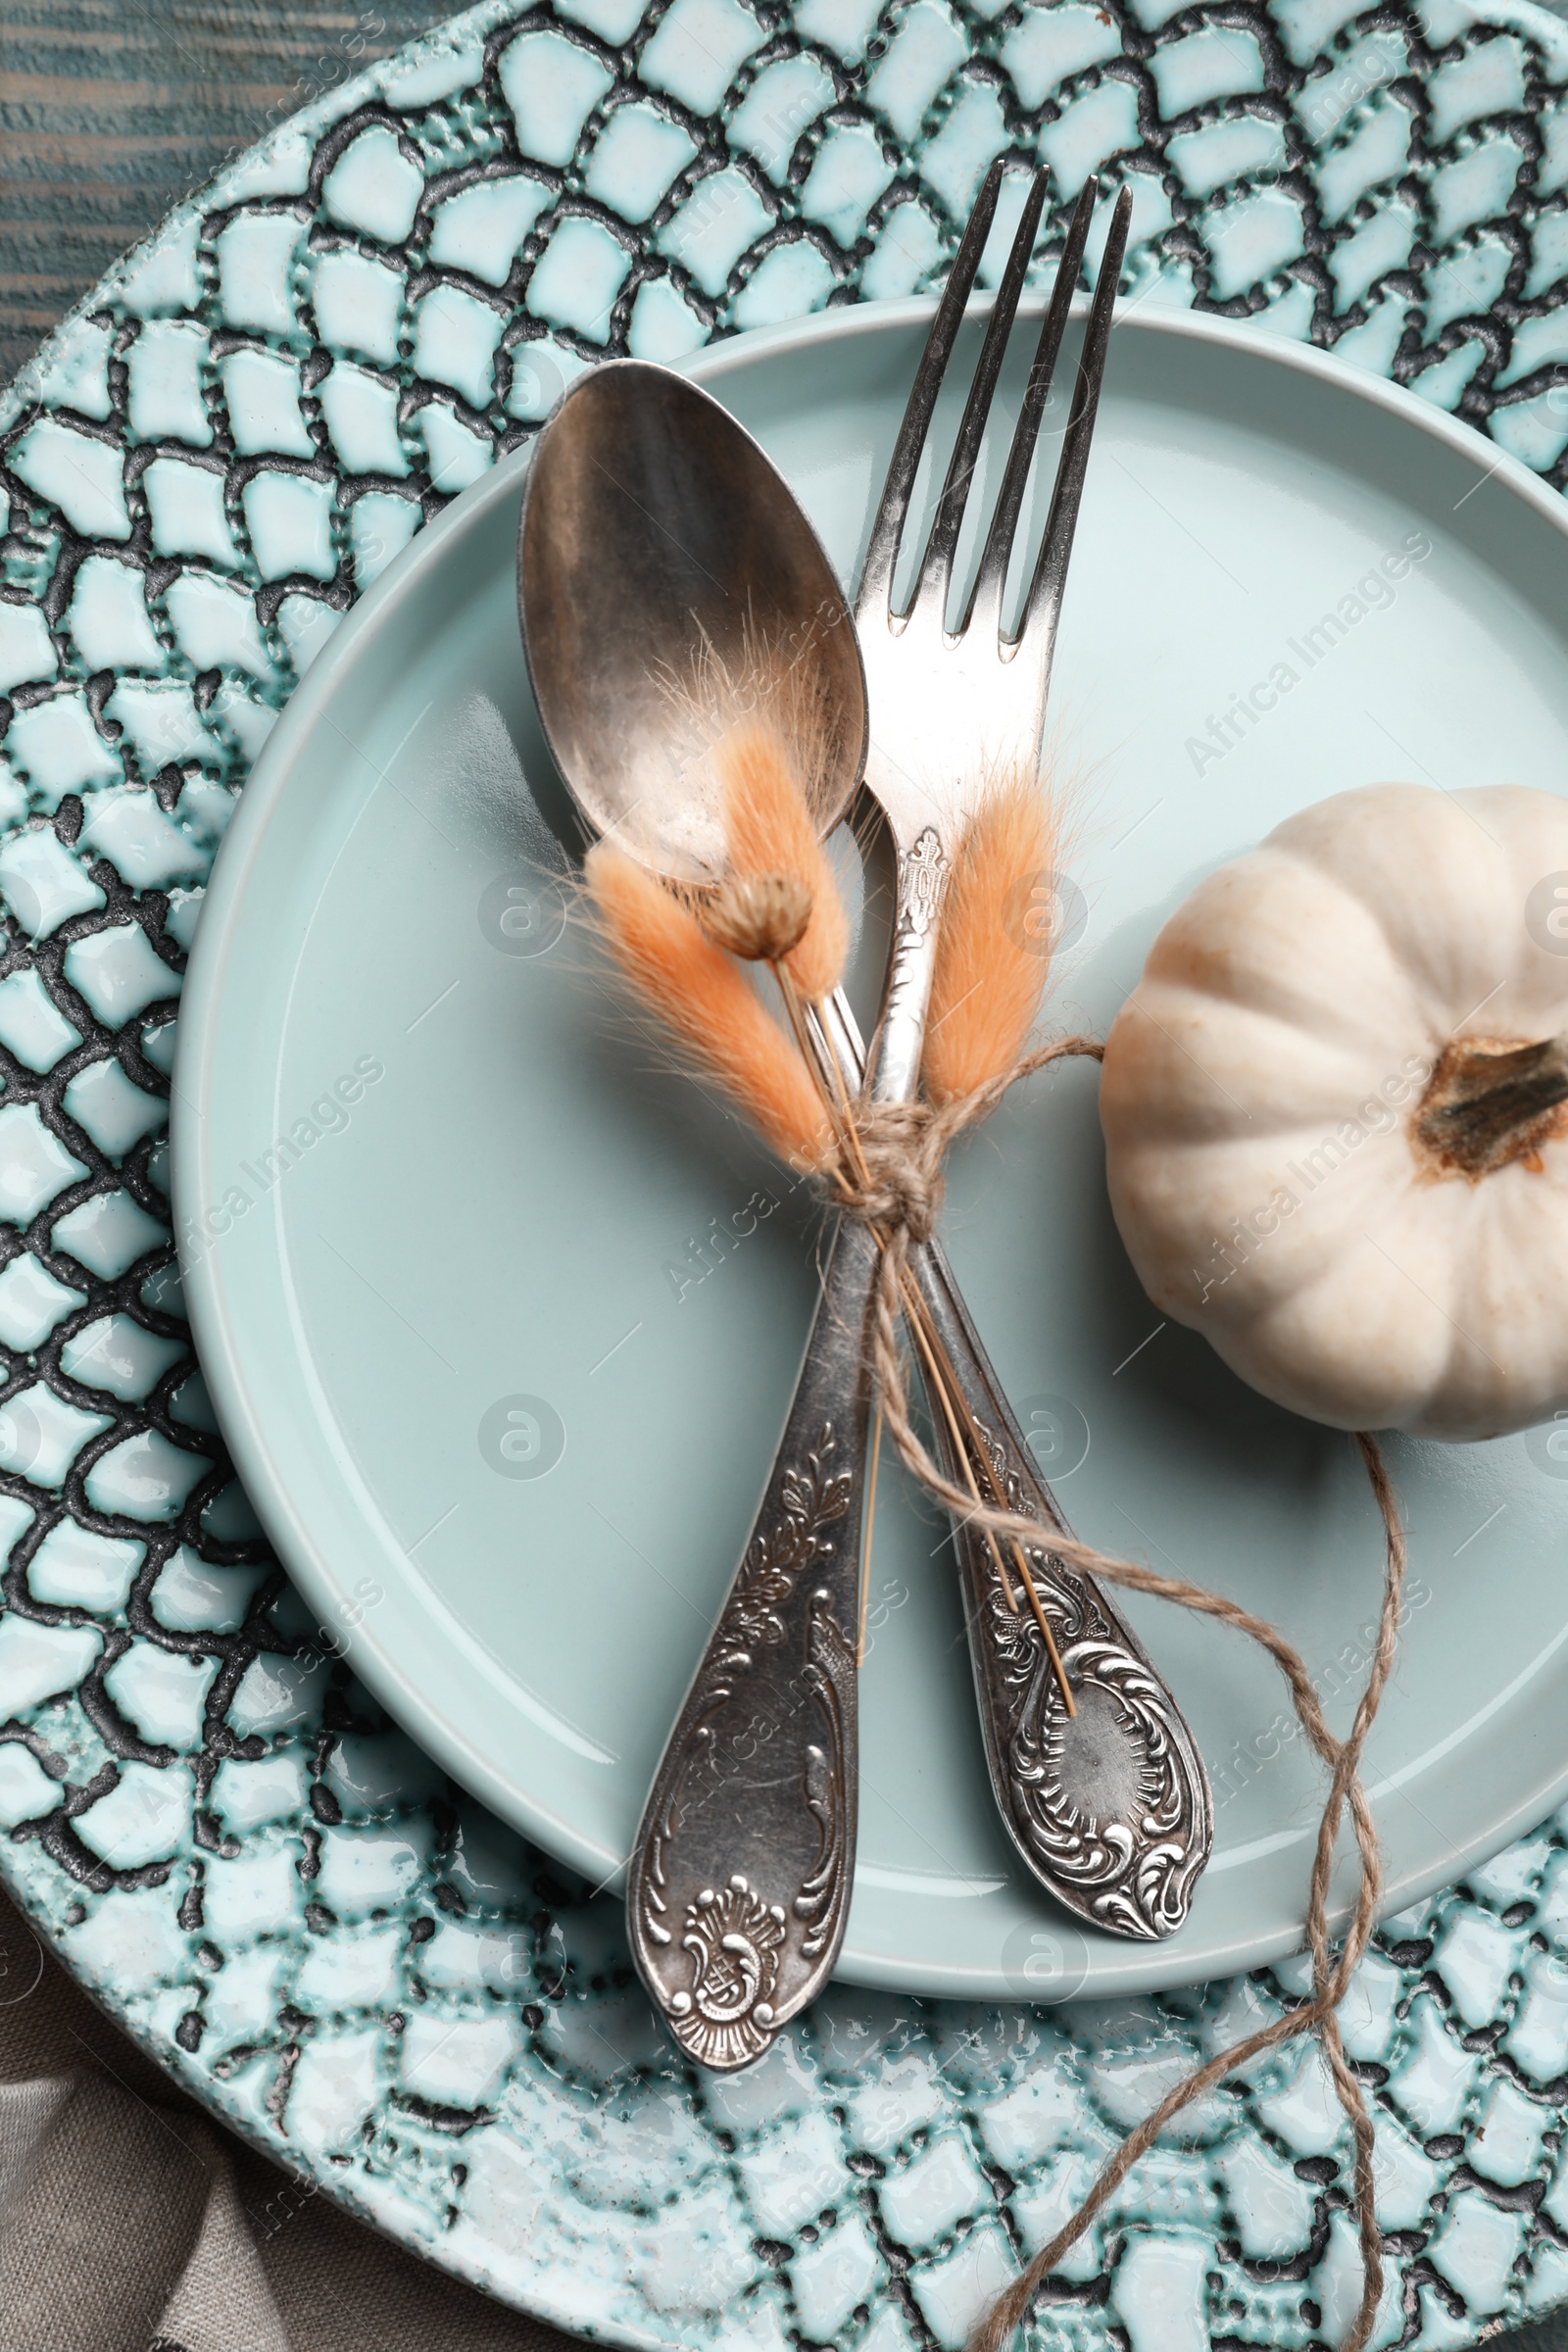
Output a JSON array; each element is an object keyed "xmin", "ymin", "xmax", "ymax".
[{"xmin": 921, "ymin": 776, "xmax": 1057, "ymax": 1103}]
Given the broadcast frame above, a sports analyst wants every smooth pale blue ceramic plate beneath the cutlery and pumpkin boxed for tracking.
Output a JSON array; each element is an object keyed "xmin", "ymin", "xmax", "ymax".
[{"xmin": 174, "ymin": 284, "xmax": 1568, "ymax": 1997}]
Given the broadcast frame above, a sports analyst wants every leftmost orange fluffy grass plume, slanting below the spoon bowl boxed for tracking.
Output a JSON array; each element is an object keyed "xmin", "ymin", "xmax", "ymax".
[{"xmin": 583, "ymin": 842, "xmax": 832, "ymax": 1166}]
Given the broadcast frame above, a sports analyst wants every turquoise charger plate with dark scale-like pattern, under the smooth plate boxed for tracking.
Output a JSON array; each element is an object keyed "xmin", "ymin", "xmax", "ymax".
[{"xmin": 0, "ymin": 0, "xmax": 1568, "ymax": 2352}]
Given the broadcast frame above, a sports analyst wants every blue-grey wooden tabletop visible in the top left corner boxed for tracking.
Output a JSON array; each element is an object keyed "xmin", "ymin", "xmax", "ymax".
[{"xmin": 0, "ymin": 0, "xmax": 452, "ymax": 381}]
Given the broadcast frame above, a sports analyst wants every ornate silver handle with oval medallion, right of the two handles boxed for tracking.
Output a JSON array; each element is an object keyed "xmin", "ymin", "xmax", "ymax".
[{"xmin": 909, "ymin": 1245, "xmax": 1213, "ymax": 1938}]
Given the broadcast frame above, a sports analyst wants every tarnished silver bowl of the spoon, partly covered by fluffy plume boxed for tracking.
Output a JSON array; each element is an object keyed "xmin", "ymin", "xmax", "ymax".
[{"xmin": 517, "ymin": 360, "xmax": 867, "ymax": 884}]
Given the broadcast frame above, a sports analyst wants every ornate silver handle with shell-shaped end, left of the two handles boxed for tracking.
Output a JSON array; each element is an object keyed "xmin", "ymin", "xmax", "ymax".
[{"xmin": 627, "ymin": 1221, "xmax": 877, "ymax": 2072}]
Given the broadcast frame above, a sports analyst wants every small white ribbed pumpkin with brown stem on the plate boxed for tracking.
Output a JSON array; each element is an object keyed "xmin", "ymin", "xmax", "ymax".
[{"xmin": 1101, "ymin": 783, "xmax": 1568, "ymax": 1440}]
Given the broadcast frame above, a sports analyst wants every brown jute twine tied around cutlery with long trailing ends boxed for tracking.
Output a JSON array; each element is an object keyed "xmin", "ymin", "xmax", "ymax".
[{"xmin": 839, "ymin": 1037, "xmax": 1405, "ymax": 2352}]
